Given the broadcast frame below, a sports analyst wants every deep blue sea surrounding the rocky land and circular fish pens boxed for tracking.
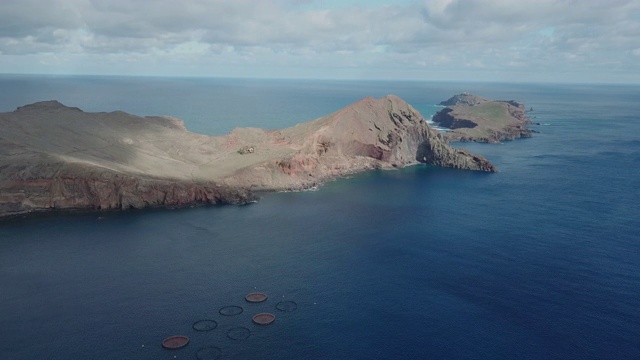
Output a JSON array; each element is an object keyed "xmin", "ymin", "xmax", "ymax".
[{"xmin": 0, "ymin": 75, "xmax": 640, "ymax": 360}]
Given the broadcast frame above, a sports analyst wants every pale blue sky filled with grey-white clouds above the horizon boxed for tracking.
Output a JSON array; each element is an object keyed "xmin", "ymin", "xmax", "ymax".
[{"xmin": 0, "ymin": 0, "xmax": 640, "ymax": 84}]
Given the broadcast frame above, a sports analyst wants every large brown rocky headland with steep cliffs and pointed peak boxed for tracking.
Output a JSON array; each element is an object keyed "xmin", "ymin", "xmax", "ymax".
[{"xmin": 0, "ymin": 95, "xmax": 496, "ymax": 216}]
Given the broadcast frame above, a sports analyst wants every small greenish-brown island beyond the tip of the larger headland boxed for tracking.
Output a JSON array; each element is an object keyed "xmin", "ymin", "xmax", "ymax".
[{"xmin": 432, "ymin": 93, "xmax": 534, "ymax": 143}]
